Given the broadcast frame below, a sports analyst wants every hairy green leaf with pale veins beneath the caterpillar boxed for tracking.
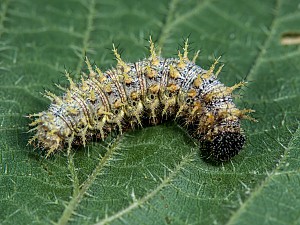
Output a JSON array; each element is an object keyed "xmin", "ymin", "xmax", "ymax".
[{"xmin": 0, "ymin": 0, "xmax": 300, "ymax": 224}]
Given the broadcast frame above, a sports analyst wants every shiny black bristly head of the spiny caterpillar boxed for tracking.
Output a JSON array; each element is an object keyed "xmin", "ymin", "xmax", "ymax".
[{"xmin": 209, "ymin": 132, "xmax": 246, "ymax": 161}]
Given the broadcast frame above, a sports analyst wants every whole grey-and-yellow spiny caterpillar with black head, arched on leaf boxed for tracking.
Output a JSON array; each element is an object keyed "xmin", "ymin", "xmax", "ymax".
[{"xmin": 28, "ymin": 37, "xmax": 253, "ymax": 161}]
